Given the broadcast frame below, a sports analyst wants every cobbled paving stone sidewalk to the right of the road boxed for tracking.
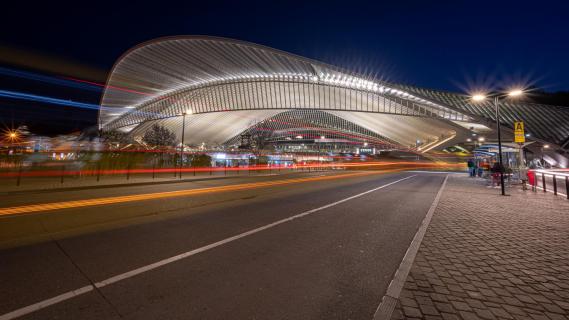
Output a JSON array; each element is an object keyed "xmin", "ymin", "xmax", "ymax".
[{"xmin": 392, "ymin": 175, "xmax": 569, "ymax": 320}]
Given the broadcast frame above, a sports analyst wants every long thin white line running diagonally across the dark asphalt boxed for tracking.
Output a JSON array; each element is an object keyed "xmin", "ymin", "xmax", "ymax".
[{"xmin": 0, "ymin": 174, "xmax": 417, "ymax": 320}]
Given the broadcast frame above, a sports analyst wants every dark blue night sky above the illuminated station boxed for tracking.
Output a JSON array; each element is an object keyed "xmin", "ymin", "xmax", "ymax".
[{"xmin": 0, "ymin": 0, "xmax": 569, "ymax": 134}]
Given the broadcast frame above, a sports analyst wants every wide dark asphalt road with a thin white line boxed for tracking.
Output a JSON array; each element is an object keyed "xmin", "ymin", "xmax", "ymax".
[{"xmin": 0, "ymin": 172, "xmax": 444, "ymax": 319}]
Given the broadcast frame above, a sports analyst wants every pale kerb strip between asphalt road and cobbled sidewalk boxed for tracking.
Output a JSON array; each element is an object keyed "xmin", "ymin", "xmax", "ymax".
[{"xmin": 373, "ymin": 175, "xmax": 449, "ymax": 320}]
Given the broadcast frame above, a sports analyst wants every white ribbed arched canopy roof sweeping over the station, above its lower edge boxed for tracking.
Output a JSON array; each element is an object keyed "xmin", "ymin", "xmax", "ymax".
[{"xmin": 99, "ymin": 36, "xmax": 467, "ymax": 128}]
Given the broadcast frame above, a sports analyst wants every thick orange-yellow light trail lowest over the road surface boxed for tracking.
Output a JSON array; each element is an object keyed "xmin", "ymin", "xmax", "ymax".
[{"xmin": 0, "ymin": 170, "xmax": 386, "ymax": 217}]
